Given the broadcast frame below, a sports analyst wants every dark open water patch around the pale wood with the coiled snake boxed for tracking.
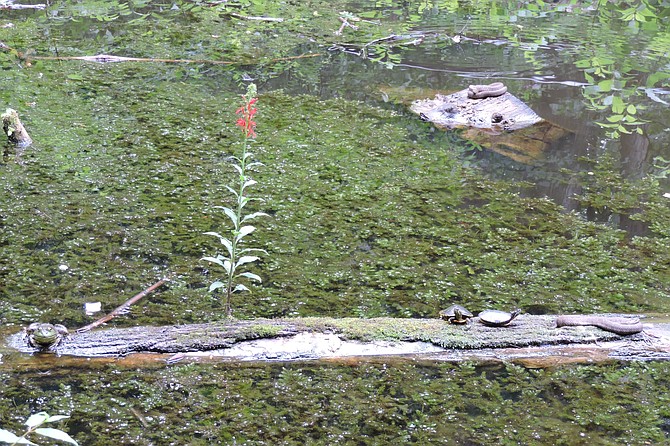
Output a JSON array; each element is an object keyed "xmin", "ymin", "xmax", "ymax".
[{"xmin": 269, "ymin": 25, "xmax": 670, "ymax": 236}]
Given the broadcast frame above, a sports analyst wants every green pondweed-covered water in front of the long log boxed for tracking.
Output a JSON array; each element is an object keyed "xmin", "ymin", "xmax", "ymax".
[{"xmin": 0, "ymin": 362, "xmax": 670, "ymax": 445}]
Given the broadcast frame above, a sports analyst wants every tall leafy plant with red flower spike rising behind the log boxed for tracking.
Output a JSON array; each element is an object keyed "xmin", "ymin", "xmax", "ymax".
[{"xmin": 202, "ymin": 84, "xmax": 267, "ymax": 317}]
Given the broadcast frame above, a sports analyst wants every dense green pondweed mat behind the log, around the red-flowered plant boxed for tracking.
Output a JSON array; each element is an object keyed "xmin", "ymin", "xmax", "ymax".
[{"xmin": 0, "ymin": 83, "xmax": 670, "ymax": 326}]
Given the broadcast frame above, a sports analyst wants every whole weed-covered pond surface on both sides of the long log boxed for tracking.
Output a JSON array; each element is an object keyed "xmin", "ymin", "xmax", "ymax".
[{"xmin": 0, "ymin": 1, "xmax": 670, "ymax": 445}]
